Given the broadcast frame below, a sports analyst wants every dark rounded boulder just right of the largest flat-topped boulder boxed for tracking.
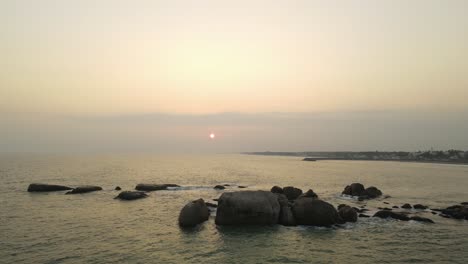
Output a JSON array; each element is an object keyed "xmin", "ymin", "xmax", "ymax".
[{"xmin": 292, "ymin": 197, "xmax": 341, "ymax": 226}]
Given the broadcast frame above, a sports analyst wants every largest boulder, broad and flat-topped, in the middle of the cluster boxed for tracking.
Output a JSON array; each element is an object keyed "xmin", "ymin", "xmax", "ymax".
[{"xmin": 215, "ymin": 191, "xmax": 281, "ymax": 225}]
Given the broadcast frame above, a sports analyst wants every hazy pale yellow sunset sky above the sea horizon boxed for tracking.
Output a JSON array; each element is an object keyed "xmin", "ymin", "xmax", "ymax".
[{"xmin": 0, "ymin": 0, "xmax": 468, "ymax": 153}]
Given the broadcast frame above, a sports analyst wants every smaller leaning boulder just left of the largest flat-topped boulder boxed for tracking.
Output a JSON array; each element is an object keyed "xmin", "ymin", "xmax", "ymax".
[{"xmin": 179, "ymin": 199, "xmax": 210, "ymax": 227}]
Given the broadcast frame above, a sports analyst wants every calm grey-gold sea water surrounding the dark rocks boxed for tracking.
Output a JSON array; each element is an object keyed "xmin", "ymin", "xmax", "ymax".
[{"xmin": 0, "ymin": 155, "xmax": 468, "ymax": 263}]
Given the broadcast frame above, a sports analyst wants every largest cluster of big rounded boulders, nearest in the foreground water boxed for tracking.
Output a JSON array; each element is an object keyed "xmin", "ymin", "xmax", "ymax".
[{"xmin": 179, "ymin": 186, "xmax": 357, "ymax": 227}]
